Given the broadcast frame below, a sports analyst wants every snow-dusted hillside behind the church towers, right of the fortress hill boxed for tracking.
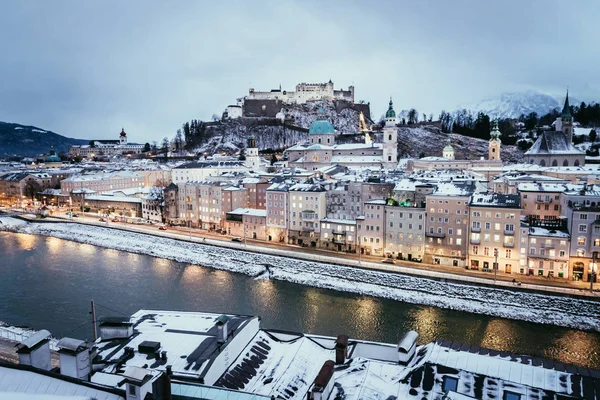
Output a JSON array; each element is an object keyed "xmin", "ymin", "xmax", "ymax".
[{"xmin": 398, "ymin": 126, "xmax": 523, "ymax": 163}]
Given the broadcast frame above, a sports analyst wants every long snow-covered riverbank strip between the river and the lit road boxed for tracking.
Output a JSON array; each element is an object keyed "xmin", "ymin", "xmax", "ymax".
[{"xmin": 0, "ymin": 218, "xmax": 600, "ymax": 331}]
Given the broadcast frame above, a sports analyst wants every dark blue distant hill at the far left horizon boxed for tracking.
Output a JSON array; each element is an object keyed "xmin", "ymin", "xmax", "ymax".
[{"xmin": 0, "ymin": 121, "xmax": 89, "ymax": 157}]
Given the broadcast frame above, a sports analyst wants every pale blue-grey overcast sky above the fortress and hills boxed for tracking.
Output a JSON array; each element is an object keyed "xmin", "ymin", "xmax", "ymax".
[{"xmin": 0, "ymin": 0, "xmax": 600, "ymax": 143}]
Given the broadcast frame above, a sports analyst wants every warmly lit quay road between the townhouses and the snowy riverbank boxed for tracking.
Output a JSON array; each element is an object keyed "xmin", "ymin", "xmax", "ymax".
[{"xmin": 5, "ymin": 208, "xmax": 600, "ymax": 300}]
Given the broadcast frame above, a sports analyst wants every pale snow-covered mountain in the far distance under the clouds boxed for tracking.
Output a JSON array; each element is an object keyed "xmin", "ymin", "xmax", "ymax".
[{"xmin": 459, "ymin": 90, "xmax": 577, "ymax": 118}]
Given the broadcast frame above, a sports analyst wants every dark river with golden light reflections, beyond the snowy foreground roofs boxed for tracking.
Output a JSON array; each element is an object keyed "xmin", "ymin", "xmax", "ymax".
[{"xmin": 0, "ymin": 232, "xmax": 600, "ymax": 369}]
